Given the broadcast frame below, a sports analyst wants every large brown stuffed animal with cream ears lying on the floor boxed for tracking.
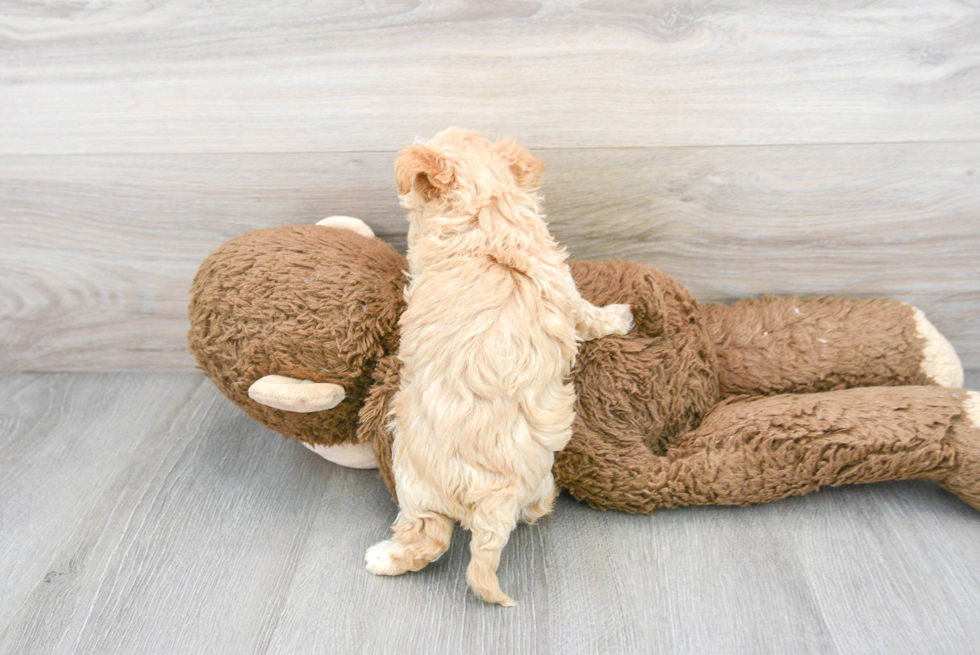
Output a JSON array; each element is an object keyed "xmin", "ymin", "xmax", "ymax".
[{"xmin": 188, "ymin": 217, "xmax": 980, "ymax": 512}]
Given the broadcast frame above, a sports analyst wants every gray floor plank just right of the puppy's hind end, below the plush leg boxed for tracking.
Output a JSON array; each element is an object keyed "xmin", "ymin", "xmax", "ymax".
[{"xmin": 547, "ymin": 502, "xmax": 836, "ymax": 655}]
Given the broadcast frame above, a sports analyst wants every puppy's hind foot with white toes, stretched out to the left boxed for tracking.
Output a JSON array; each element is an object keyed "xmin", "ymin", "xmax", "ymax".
[{"xmin": 364, "ymin": 512, "xmax": 453, "ymax": 575}]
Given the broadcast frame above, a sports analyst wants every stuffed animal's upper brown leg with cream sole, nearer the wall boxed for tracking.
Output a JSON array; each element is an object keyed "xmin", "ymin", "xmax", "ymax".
[{"xmin": 703, "ymin": 297, "xmax": 963, "ymax": 396}]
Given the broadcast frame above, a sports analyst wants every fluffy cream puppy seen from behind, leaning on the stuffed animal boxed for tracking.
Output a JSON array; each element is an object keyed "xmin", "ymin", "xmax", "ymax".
[{"xmin": 365, "ymin": 128, "xmax": 633, "ymax": 607}]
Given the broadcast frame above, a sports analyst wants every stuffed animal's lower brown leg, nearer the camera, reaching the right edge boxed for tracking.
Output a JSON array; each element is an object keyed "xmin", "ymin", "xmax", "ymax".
[{"xmin": 555, "ymin": 386, "xmax": 980, "ymax": 513}]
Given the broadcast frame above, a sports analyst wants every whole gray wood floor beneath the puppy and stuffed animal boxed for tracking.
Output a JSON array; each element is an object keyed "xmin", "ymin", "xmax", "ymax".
[{"xmin": 0, "ymin": 373, "xmax": 980, "ymax": 655}]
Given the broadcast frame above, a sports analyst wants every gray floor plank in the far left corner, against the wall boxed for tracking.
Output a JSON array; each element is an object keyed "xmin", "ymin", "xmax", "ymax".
[{"xmin": 0, "ymin": 374, "xmax": 202, "ymax": 627}]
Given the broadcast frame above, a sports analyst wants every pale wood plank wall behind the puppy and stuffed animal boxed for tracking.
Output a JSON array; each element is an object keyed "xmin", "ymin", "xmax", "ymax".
[{"xmin": 0, "ymin": 0, "xmax": 980, "ymax": 371}]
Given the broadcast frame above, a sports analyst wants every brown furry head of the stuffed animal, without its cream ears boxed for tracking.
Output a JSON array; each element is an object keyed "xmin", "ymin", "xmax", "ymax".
[{"xmin": 187, "ymin": 225, "xmax": 407, "ymax": 446}]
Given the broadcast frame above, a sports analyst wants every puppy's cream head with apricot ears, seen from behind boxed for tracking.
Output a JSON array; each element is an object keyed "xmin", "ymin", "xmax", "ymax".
[{"xmin": 395, "ymin": 127, "xmax": 544, "ymax": 214}]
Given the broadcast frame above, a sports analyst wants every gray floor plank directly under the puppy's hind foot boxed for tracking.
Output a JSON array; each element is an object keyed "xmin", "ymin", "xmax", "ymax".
[{"xmin": 269, "ymin": 463, "xmax": 556, "ymax": 655}]
